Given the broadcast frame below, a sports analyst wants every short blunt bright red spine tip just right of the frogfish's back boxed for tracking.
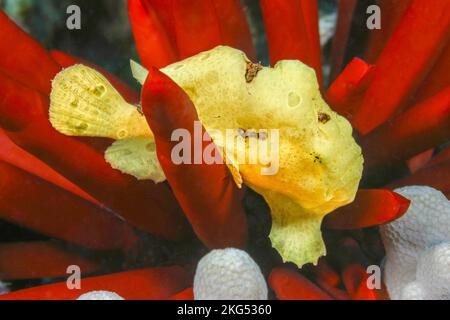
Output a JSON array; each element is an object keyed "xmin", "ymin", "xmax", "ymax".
[{"xmin": 325, "ymin": 58, "xmax": 375, "ymax": 119}]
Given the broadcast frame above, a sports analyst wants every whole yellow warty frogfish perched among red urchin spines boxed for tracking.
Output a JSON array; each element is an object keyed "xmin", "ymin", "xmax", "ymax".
[{"xmin": 50, "ymin": 46, "xmax": 363, "ymax": 267}]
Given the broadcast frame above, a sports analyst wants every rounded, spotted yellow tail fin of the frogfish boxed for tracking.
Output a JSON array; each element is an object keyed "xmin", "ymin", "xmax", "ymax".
[{"xmin": 49, "ymin": 64, "xmax": 152, "ymax": 140}]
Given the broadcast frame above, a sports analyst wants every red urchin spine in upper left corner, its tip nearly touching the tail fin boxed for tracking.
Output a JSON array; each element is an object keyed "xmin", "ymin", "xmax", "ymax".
[{"xmin": 0, "ymin": 10, "xmax": 61, "ymax": 94}]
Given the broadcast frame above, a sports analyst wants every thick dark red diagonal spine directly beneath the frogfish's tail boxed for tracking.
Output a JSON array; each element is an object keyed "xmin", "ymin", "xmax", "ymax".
[{"xmin": 13, "ymin": 119, "xmax": 186, "ymax": 240}]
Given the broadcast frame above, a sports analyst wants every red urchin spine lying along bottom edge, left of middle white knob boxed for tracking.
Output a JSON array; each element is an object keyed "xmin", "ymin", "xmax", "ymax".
[{"xmin": 0, "ymin": 266, "xmax": 192, "ymax": 300}]
